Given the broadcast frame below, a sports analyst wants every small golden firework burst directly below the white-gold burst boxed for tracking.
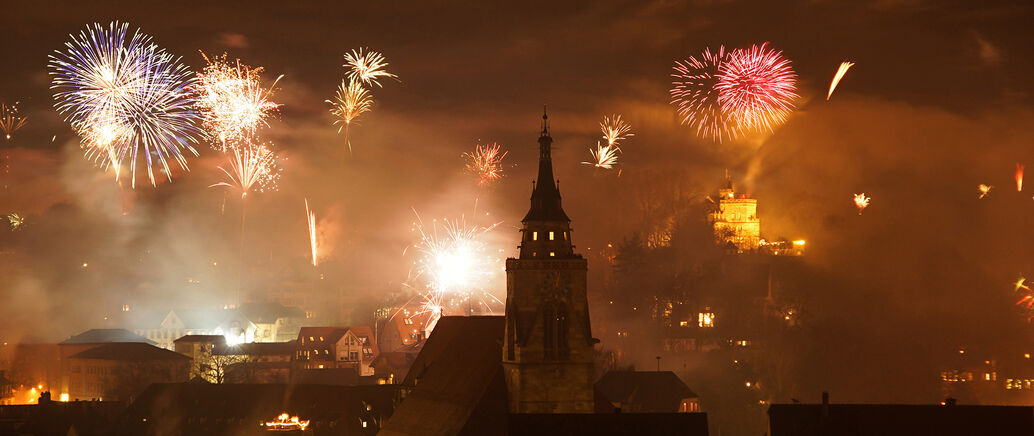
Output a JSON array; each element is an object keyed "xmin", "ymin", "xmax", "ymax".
[{"xmin": 209, "ymin": 140, "xmax": 280, "ymax": 198}]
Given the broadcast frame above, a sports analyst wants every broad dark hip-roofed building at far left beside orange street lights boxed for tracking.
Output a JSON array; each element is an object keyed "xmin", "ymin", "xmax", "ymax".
[{"xmin": 68, "ymin": 342, "xmax": 190, "ymax": 401}]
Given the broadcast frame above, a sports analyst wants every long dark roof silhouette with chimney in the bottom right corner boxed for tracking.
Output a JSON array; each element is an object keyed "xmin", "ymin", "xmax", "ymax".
[{"xmin": 768, "ymin": 404, "xmax": 1034, "ymax": 436}]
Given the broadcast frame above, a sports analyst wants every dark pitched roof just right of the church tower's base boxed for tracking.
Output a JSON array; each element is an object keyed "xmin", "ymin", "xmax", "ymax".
[{"xmin": 596, "ymin": 371, "xmax": 697, "ymax": 412}]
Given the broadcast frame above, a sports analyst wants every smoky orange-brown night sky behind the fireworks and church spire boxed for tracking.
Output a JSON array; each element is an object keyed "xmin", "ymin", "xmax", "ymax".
[{"xmin": 0, "ymin": 0, "xmax": 1034, "ymax": 401}]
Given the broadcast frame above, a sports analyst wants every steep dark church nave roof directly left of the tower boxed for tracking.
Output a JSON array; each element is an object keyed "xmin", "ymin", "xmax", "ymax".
[{"xmin": 381, "ymin": 316, "xmax": 506, "ymax": 436}]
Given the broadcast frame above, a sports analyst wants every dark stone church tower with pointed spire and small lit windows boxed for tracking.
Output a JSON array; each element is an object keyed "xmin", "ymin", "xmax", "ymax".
[{"xmin": 503, "ymin": 109, "xmax": 598, "ymax": 413}]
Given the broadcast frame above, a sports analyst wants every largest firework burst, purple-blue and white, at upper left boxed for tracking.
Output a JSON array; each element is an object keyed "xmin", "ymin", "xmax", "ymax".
[{"xmin": 48, "ymin": 22, "xmax": 201, "ymax": 187}]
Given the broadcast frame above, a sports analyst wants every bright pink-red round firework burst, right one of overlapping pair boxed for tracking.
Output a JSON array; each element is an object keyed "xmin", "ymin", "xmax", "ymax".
[{"xmin": 714, "ymin": 42, "xmax": 797, "ymax": 131}]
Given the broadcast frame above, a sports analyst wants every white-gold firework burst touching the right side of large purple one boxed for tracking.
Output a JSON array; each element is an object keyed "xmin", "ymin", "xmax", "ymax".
[{"xmin": 194, "ymin": 53, "xmax": 283, "ymax": 147}]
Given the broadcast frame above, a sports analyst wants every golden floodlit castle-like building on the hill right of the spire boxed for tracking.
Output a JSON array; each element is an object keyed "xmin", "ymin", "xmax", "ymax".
[{"xmin": 709, "ymin": 180, "xmax": 761, "ymax": 251}]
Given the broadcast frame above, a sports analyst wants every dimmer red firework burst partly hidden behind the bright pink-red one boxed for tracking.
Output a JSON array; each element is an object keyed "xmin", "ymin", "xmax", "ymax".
[{"xmin": 669, "ymin": 46, "xmax": 740, "ymax": 143}]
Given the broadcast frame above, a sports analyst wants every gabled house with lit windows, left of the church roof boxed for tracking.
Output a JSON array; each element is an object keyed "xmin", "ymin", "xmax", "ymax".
[{"xmin": 295, "ymin": 325, "xmax": 378, "ymax": 376}]
